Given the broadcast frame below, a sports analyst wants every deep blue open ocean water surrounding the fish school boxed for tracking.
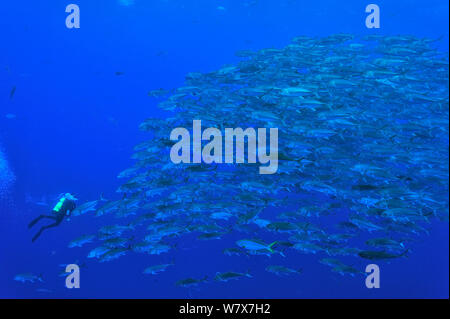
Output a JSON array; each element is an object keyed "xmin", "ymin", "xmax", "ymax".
[{"xmin": 0, "ymin": 0, "xmax": 449, "ymax": 298}]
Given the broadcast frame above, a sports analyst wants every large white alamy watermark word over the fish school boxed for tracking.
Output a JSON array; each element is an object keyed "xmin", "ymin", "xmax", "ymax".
[{"xmin": 170, "ymin": 120, "xmax": 278, "ymax": 174}]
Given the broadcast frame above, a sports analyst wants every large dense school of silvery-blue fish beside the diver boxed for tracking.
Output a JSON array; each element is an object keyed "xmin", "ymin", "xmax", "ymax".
[{"xmin": 25, "ymin": 34, "xmax": 449, "ymax": 287}]
